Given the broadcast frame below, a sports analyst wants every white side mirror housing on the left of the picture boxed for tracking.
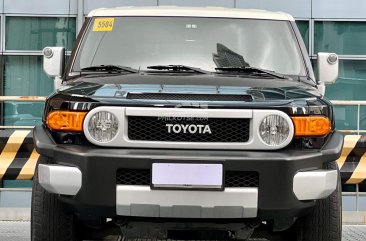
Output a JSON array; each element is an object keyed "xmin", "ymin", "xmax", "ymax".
[{"xmin": 43, "ymin": 47, "xmax": 65, "ymax": 78}]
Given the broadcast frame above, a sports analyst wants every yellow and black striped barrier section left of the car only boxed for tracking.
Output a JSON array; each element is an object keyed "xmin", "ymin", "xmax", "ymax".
[{"xmin": 0, "ymin": 129, "xmax": 39, "ymax": 180}]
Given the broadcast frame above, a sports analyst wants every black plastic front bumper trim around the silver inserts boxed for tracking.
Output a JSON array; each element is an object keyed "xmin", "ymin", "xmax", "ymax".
[{"xmin": 34, "ymin": 126, "xmax": 343, "ymax": 220}]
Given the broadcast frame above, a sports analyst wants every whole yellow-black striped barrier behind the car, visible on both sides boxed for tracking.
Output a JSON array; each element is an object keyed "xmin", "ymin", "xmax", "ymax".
[{"xmin": 0, "ymin": 129, "xmax": 366, "ymax": 184}]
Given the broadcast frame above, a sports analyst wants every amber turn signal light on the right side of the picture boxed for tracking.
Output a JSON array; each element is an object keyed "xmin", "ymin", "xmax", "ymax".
[{"xmin": 291, "ymin": 116, "xmax": 331, "ymax": 137}]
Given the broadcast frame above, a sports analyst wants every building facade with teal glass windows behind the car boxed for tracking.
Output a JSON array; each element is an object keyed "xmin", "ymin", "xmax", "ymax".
[{"xmin": 0, "ymin": 0, "xmax": 366, "ymax": 210}]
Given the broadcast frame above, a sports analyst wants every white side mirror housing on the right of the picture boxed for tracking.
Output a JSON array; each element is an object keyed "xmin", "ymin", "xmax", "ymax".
[{"xmin": 318, "ymin": 53, "xmax": 339, "ymax": 84}]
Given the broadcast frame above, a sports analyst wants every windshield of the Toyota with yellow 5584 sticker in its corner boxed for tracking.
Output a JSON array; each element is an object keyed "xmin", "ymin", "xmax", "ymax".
[{"xmin": 72, "ymin": 17, "xmax": 306, "ymax": 76}]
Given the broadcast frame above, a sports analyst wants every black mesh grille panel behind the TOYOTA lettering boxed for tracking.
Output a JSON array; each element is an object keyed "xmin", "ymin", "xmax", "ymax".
[{"xmin": 128, "ymin": 116, "xmax": 249, "ymax": 142}]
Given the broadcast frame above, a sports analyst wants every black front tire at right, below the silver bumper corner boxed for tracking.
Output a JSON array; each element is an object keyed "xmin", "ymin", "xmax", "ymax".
[{"xmin": 297, "ymin": 162, "xmax": 342, "ymax": 241}]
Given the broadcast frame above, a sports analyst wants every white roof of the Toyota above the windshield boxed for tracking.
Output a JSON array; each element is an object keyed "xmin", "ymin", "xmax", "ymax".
[{"xmin": 88, "ymin": 6, "xmax": 294, "ymax": 21}]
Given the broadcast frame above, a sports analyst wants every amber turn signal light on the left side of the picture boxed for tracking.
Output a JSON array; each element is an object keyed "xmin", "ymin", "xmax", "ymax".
[{"xmin": 47, "ymin": 111, "xmax": 87, "ymax": 131}]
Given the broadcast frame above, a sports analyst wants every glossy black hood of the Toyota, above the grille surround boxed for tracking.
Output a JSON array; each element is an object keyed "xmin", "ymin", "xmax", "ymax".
[{"xmin": 46, "ymin": 72, "xmax": 332, "ymax": 119}]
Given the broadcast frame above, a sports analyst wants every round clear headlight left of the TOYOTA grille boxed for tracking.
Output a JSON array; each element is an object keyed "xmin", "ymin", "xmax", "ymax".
[{"xmin": 88, "ymin": 111, "xmax": 118, "ymax": 142}]
